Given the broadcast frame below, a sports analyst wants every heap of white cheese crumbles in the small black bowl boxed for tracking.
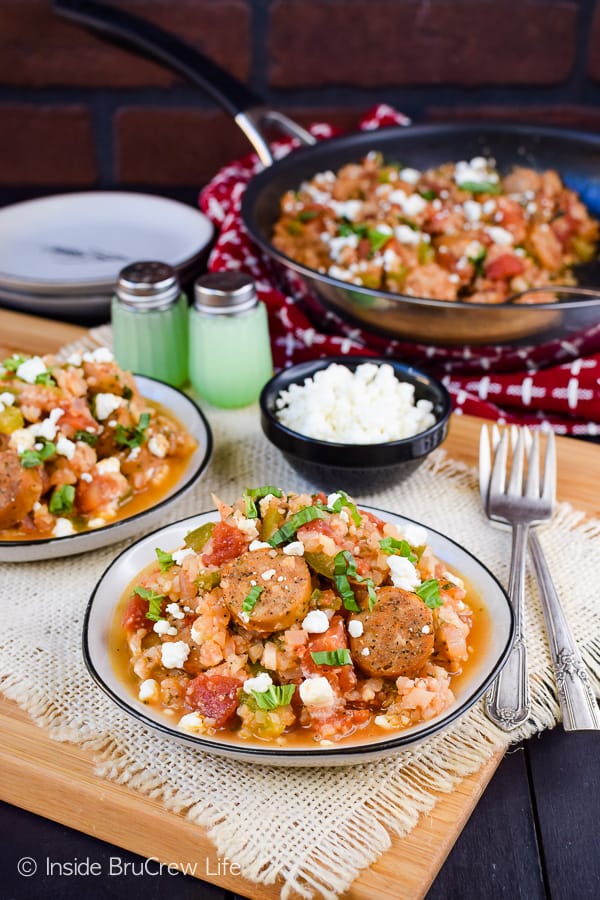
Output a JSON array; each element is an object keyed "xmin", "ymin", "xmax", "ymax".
[{"xmin": 276, "ymin": 363, "xmax": 435, "ymax": 444}]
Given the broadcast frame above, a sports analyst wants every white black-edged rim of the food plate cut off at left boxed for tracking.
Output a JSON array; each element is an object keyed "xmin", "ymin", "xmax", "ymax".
[{"xmin": 0, "ymin": 375, "xmax": 213, "ymax": 562}]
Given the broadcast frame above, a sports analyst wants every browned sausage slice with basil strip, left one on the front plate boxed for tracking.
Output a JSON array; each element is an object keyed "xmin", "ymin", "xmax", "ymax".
[{"xmin": 221, "ymin": 550, "xmax": 312, "ymax": 634}]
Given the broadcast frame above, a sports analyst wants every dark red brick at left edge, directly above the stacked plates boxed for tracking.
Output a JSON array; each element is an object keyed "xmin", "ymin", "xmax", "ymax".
[{"xmin": 0, "ymin": 104, "xmax": 97, "ymax": 187}]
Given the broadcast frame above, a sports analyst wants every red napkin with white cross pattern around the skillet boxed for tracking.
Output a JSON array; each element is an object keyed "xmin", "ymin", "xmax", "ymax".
[{"xmin": 200, "ymin": 105, "xmax": 600, "ymax": 436}]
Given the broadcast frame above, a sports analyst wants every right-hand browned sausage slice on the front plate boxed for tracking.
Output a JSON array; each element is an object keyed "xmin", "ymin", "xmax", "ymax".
[{"xmin": 350, "ymin": 587, "xmax": 433, "ymax": 678}]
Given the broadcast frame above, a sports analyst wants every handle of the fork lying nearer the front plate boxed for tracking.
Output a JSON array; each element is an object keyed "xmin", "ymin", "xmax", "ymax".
[{"xmin": 485, "ymin": 523, "xmax": 530, "ymax": 731}]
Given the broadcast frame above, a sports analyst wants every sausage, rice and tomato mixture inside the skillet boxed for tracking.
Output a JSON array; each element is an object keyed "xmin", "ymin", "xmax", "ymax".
[{"xmin": 273, "ymin": 152, "xmax": 598, "ymax": 303}]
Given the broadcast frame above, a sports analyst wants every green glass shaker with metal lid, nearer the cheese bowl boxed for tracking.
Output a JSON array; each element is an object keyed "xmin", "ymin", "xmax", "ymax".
[{"xmin": 190, "ymin": 271, "xmax": 273, "ymax": 409}]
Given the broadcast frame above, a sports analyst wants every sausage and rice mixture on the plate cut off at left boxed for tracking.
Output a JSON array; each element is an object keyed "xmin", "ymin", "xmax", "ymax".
[{"xmin": 0, "ymin": 347, "xmax": 195, "ymax": 541}]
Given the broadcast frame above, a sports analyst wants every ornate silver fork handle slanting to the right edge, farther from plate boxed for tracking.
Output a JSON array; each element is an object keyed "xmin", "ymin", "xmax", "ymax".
[{"xmin": 529, "ymin": 531, "xmax": 600, "ymax": 731}]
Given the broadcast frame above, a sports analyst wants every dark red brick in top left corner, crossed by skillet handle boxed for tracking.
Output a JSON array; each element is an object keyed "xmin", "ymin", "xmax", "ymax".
[{"xmin": 0, "ymin": 0, "xmax": 250, "ymax": 87}]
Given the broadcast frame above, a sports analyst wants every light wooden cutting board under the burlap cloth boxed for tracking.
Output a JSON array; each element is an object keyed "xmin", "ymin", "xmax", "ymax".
[{"xmin": 0, "ymin": 310, "xmax": 600, "ymax": 900}]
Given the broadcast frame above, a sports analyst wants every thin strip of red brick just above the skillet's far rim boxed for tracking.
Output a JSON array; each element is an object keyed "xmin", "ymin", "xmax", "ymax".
[{"xmin": 425, "ymin": 106, "xmax": 600, "ymax": 131}]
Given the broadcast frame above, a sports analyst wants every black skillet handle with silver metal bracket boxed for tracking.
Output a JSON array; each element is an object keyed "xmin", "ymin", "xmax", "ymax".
[{"xmin": 54, "ymin": 0, "xmax": 315, "ymax": 166}]
